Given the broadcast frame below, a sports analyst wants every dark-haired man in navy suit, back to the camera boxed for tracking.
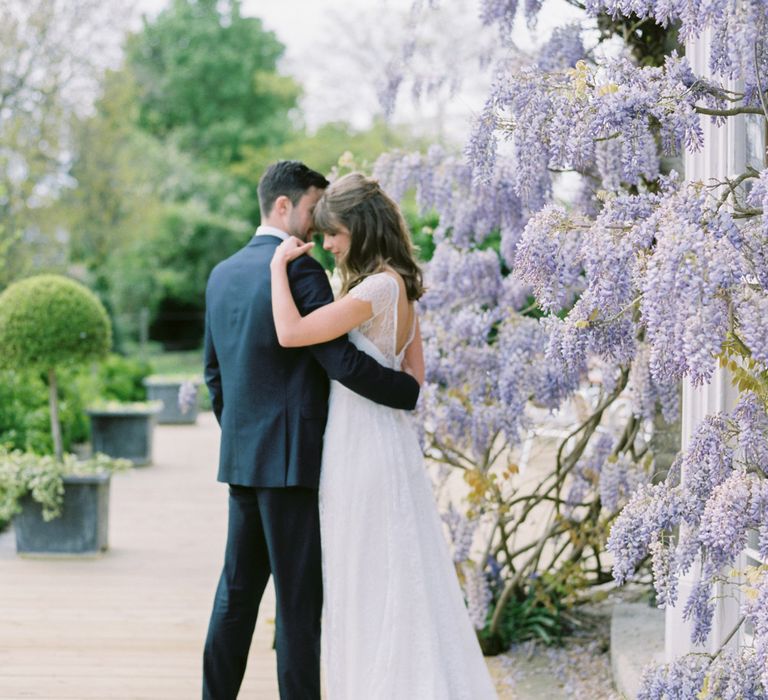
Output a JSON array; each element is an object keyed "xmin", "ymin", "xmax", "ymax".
[{"xmin": 203, "ymin": 161, "xmax": 419, "ymax": 700}]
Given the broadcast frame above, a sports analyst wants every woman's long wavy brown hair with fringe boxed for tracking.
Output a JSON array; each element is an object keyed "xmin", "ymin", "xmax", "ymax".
[{"xmin": 313, "ymin": 173, "xmax": 424, "ymax": 301}]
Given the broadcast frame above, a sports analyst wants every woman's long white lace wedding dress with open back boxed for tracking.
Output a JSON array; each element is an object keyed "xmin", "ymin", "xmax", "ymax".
[{"xmin": 320, "ymin": 273, "xmax": 497, "ymax": 700}]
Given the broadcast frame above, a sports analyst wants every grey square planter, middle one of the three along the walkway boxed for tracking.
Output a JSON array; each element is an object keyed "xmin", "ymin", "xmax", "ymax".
[{"xmin": 88, "ymin": 407, "xmax": 160, "ymax": 467}]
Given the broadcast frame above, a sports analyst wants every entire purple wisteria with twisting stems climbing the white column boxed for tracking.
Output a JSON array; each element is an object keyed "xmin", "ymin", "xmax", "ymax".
[{"xmin": 376, "ymin": 0, "xmax": 768, "ymax": 676}]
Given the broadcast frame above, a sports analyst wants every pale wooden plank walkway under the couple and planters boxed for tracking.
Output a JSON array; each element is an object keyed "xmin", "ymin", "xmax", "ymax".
[{"xmin": 0, "ymin": 413, "xmax": 516, "ymax": 700}]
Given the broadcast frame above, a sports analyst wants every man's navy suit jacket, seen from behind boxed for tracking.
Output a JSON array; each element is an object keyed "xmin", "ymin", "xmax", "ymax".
[{"xmin": 205, "ymin": 235, "xmax": 419, "ymax": 488}]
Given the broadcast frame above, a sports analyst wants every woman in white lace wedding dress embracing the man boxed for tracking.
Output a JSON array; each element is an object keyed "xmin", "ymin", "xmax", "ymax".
[{"xmin": 271, "ymin": 173, "xmax": 496, "ymax": 700}]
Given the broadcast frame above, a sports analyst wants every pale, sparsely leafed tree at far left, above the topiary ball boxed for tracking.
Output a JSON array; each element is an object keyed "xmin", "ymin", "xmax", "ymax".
[{"xmin": 0, "ymin": 0, "xmax": 128, "ymax": 287}]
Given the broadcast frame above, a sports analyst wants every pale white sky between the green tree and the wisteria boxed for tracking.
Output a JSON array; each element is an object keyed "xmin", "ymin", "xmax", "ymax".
[{"xmin": 130, "ymin": 0, "xmax": 578, "ymax": 140}]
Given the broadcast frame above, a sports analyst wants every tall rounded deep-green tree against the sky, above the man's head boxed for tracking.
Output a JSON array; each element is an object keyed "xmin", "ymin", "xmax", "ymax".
[{"xmin": 127, "ymin": 0, "xmax": 300, "ymax": 164}]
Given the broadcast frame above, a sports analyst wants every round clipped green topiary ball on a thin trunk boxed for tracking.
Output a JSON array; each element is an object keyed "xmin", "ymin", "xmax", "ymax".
[{"xmin": 0, "ymin": 275, "xmax": 112, "ymax": 370}]
